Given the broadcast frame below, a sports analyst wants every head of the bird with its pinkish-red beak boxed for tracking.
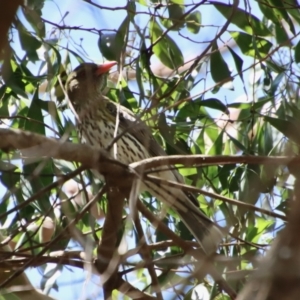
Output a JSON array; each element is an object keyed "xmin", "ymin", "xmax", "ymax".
[{"xmin": 66, "ymin": 61, "xmax": 117, "ymax": 107}]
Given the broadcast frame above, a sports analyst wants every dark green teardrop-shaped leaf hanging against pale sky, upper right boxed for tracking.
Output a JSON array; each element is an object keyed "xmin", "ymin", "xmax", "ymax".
[{"xmin": 210, "ymin": 42, "xmax": 231, "ymax": 83}]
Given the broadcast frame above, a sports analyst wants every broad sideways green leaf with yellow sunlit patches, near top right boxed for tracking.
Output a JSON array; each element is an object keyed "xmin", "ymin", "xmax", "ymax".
[{"xmin": 229, "ymin": 31, "xmax": 273, "ymax": 58}]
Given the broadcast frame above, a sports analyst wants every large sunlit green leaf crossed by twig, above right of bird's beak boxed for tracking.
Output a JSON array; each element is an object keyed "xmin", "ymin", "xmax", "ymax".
[{"xmin": 150, "ymin": 19, "xmax": 183, "ymax": 70}]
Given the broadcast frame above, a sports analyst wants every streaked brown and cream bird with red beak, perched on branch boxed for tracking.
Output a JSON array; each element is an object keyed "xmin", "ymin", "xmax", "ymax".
[{"xmin": 65, "ymin": 61, "xmax": 224, "ymax": 255}]
